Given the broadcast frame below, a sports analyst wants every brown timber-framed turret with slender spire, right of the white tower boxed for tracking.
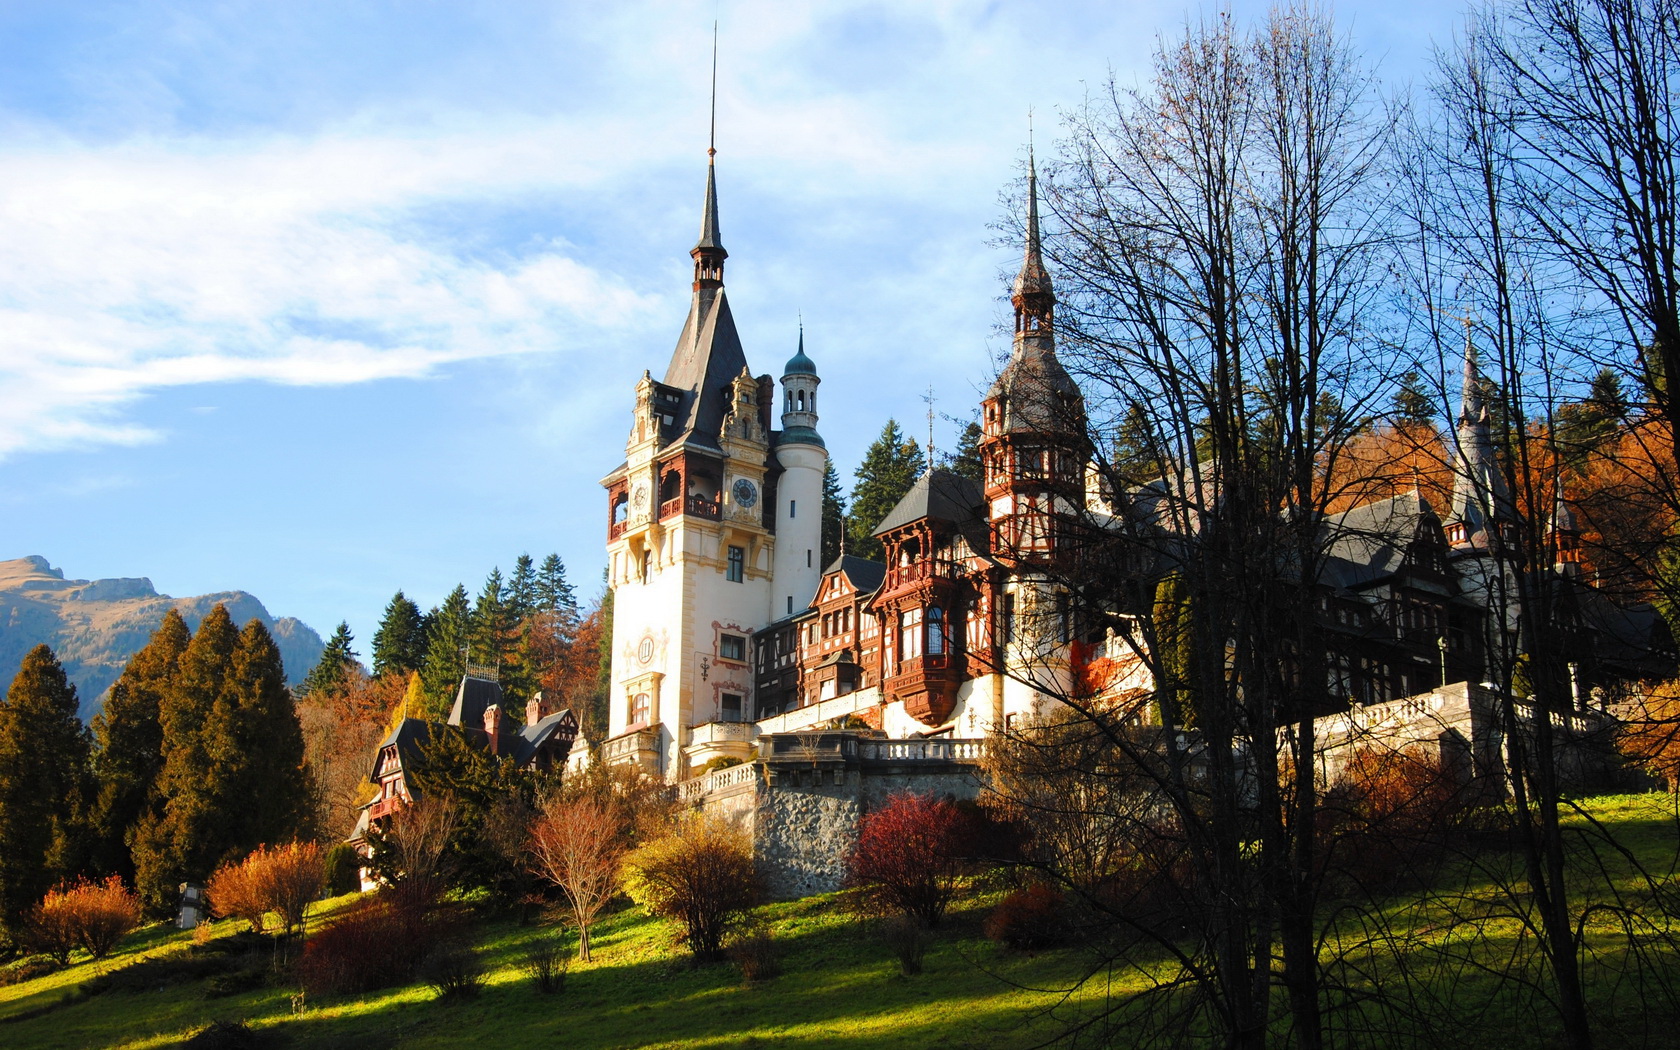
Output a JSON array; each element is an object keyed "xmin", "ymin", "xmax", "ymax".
[{"xmin": 979, "ymin": 147, "xmax": 1090, "ymax": 566}]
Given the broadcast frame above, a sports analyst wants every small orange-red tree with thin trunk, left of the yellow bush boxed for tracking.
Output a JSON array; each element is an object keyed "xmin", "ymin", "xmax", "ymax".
[{"xmin": 529, "ymin": 798, "xmax": 628, "ymax": 963}]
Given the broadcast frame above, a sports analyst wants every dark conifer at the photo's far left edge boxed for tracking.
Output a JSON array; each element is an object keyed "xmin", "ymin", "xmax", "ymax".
[{"xmin": 0, "ymin": 645, "xmax": 92, "ymax": 932}]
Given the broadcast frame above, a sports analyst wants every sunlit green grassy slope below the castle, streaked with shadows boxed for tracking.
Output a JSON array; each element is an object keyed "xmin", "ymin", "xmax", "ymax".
[{"xmin": 0, "ymin": 796, "xmax": 1680, "ymax": 1050}]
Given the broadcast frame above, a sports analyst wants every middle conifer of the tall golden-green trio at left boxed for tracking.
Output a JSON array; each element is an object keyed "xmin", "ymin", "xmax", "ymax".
[{"xmin": 134, "ymin": 605, "xmax": 239, "ymax": 914}]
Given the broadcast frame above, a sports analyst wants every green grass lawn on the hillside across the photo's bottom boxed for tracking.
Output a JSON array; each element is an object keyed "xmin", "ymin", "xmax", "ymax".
[{"xmin": 0, "ymin": 795, "xmax": 1680, "ymax": 1050}]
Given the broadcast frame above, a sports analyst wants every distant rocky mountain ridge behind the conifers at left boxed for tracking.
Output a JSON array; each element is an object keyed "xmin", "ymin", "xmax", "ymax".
[{"xmin": 0, "ymin": 554, "xmax": 324, "ymax": 719}]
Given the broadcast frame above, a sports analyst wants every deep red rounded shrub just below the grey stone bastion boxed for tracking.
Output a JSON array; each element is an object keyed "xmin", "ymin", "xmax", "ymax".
[{"xmin": 847, "ymin": 791, "xmax": 971, "ymax": 927}]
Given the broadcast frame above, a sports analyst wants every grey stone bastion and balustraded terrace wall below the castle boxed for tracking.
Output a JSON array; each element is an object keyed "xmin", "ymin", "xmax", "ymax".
[{"xmin": 679, "ymin": 729, "xmax": 984, "ymax": 899}]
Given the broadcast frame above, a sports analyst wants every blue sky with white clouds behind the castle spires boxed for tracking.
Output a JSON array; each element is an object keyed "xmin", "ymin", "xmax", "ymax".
[{"xmin": 0, "ymin": 0, "xmax": 1462, "ymax": 657}]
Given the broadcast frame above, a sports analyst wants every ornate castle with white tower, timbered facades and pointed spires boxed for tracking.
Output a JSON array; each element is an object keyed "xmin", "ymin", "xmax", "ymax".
[{"xmin": 600, "ymin": 147, "xmax": 1658, "ymax": 781}]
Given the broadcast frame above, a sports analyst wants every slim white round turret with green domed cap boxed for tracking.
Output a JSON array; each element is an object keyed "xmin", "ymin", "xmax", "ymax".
[{"xmin": 769, "ymin": 324, "xmax": 828, "ymax": 620}]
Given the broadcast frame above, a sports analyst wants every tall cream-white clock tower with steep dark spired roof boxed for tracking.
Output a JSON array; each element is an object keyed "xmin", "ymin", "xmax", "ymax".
[{"xmin": 601, "ymin": 151, "xmax": 772, "ymax": 780}]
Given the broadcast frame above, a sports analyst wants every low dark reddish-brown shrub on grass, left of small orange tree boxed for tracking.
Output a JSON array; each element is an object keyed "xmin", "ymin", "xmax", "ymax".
[{"xmin": 297, "ymin": 895, "xmax": 449, "ymax": 995}]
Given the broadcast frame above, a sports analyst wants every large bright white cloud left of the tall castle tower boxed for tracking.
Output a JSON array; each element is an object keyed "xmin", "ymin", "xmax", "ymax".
[{"xmin": 0, "ymin": 128, "xmax": 661, "ymax": 457}]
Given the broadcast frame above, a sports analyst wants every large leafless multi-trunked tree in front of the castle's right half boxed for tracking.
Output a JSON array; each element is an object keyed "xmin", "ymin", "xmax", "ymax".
[{"xmin": 1016, "ymin": 8, "xmax": 1401, "ymax": 1047}]
